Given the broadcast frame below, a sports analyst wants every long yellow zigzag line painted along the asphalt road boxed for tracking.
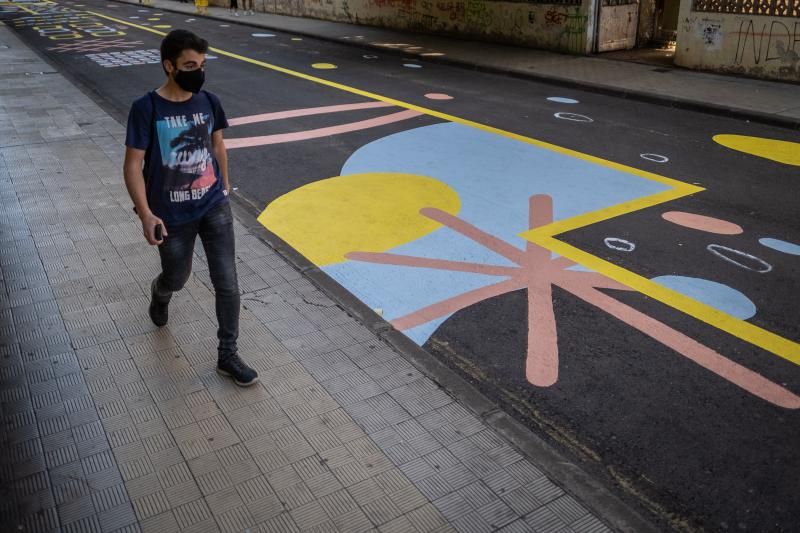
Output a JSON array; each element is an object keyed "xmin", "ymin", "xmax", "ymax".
[{"xmin": 42, "ymin": 2, "xmax": 800, "ymax": 365}]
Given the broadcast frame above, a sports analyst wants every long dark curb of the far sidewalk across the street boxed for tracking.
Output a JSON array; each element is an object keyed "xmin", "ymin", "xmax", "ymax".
[{"xmin": 113, "ymin": 0, "xmax": 800, "ymax": 130}]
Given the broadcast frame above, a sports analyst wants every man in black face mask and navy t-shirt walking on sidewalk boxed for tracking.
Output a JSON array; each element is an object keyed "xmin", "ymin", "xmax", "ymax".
[{"xmin": 124, "ymin": 30, "xmax": 258, "ymax": 386}]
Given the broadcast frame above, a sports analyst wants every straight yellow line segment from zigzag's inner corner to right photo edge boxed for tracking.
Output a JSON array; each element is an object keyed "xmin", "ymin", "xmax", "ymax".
[{"xmin": 526, "ymin": 232, "xmax": 800, "ymax": 365}]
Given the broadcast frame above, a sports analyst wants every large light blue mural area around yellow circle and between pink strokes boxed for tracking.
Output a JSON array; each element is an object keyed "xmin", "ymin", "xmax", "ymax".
[{"xmin": 316, "ymin": 123, "xmax": 668, "ymax": 345}]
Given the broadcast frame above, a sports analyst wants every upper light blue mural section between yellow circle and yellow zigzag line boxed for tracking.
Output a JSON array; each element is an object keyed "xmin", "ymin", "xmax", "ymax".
[{"xmin": 342, "ymin": 123, "xmax": 669, "ymax": 241}]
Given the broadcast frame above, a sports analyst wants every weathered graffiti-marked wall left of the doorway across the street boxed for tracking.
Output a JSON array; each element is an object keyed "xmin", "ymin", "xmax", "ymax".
[{"xmin": 210, "ymin": 0, "xmax": 590, "ymax": 53}]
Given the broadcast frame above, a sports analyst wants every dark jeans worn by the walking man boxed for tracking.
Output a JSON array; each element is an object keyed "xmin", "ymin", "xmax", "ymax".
[{"xmin": 155, "ymin": 199, "xmax": 239, "ymax": 359}]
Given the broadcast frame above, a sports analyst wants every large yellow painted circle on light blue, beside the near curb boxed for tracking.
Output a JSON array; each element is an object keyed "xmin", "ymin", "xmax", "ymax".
[{"xmin": 258, "ymin": 173, "xmax": 461, "ymax": 266}]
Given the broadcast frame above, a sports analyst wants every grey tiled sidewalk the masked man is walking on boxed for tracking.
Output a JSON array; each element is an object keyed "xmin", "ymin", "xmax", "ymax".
[{"xmin": 0, "ymin": 25, "xmax": 608, "ymax": 533}]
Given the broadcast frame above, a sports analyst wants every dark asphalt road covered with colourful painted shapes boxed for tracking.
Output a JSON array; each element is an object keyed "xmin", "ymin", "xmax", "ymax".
[{"xmin": 0, "ymin": 0, "xmax": 800, "ymax": 532}]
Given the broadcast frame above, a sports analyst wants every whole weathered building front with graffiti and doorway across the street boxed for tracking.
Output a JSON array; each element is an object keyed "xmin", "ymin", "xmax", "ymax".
[{"xmin": 212, "ymin": 0, "xmax": 800, "ymax": 81}]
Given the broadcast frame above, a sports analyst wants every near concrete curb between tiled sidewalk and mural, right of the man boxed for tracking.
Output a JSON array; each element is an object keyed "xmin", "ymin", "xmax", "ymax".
[{"xmin": 231, "ymin": 195, "xmax": 666, "ymax": 533}]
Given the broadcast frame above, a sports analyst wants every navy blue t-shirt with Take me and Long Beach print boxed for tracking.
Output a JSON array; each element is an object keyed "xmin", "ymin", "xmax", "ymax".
[{"xmin": 125, "ymin": 91, "xmax": 228, "ymax": 224}]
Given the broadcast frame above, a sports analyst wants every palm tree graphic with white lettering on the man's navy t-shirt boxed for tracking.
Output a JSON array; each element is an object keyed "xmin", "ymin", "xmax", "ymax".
[{"xmin": 156, "ymin": 113, "xmax": 217, "ymax": 203}]
